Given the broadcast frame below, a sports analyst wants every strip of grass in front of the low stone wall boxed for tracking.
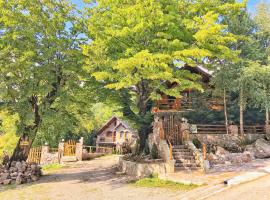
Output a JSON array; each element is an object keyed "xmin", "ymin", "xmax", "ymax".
[{"xmin": 131, "ymin": 177, "xmax": 199, "ymax": 191}]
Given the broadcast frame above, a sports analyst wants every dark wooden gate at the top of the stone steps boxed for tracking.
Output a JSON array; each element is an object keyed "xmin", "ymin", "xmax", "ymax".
[{"xmin": 162, "ymin": 114, "xmax": 183, "ymax": 145}]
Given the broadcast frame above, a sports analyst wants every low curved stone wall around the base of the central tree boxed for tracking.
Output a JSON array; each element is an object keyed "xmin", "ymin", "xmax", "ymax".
[{"xmin": 118, "ymin": 157, "xmax": 174, "ymax": 178}]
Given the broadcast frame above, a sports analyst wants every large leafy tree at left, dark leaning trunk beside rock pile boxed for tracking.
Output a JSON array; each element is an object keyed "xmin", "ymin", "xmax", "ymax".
[{"xmin": 0, "ymin": 0, "xmax": 94, "ymax": 160}]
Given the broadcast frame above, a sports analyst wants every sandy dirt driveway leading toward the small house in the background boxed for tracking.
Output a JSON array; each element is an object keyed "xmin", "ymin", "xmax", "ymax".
[{"xmin": 0, "ymin": 156, "xmax": 190, "ymax": 200}]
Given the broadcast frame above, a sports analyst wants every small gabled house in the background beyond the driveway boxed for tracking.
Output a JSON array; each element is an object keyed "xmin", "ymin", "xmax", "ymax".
[{"xmin": 96, "ymin": 116, "xmax": 137, "ymax": 147}]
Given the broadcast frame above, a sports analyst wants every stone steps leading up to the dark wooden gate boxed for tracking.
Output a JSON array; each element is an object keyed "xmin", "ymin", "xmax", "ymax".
[{"xmin": 173, "ymin": 145, "xmax": 201, "ymax": 171}]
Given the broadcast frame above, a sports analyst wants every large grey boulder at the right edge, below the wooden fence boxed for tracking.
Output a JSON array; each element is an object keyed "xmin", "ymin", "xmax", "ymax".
[{"xmin": 245, "ymin": 138, "xmax": 270, "ymax": 158}]
